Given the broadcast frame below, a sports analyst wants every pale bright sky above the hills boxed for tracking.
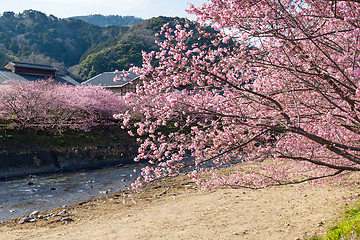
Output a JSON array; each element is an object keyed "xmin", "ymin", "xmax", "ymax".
[{"xmin": 0, "ymin": 0, "xmax": 208, "ymax": 19}]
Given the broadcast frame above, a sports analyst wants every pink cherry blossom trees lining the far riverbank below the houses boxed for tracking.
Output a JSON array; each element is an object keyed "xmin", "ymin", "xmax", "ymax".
[{"xmin": 0, "ymin": 80, "xmax": 126, "ymax": 131}]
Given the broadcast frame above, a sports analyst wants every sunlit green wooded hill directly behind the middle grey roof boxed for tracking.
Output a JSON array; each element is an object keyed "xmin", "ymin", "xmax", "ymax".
[{"xmin": 79, "ymin": 17, "xmax": 218, "ymax": 79}]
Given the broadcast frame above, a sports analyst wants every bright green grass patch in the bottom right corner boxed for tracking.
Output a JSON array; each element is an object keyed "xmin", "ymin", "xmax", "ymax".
[{"xmin": 310, "ymin": 205, "xmax": 360, "ymax": 240}]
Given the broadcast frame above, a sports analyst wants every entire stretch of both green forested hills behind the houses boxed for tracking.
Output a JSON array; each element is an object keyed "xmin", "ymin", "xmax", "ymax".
[{"xmin": 0, "ymin": 10, "xmax": 214, "ymax": 81}]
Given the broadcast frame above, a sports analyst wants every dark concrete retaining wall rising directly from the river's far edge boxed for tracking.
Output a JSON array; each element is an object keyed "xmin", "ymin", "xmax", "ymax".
[{"xmin": 0, "ymin": 145, "xmax": 136, "ymax": 178}]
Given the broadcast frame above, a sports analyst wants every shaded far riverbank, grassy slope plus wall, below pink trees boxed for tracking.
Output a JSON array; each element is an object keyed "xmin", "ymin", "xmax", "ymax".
[{"xmin": 0, "ymin": 125, "xmax": 138, "ymax": 180}]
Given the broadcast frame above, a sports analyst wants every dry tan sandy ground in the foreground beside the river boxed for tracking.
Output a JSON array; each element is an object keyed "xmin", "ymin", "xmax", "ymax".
[{"xmin": 0, "ymin": 168, "xmax": 358, "ymax": 240}]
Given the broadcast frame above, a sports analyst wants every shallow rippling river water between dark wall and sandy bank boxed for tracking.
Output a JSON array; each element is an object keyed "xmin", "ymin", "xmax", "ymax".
[{"xmin": 0, "ymin": 164, "xmax": 142, "ymax": 221}]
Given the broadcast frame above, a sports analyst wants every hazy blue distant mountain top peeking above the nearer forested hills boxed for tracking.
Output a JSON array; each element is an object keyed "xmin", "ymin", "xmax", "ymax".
[{"xmin": 71, "ymin": 14, "xmax": 144, "ymax": 27}]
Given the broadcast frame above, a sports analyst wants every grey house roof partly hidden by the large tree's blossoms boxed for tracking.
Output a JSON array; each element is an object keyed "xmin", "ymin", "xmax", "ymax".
[{"xmin": 82, "ymin": 72, "xmax": 140, "ymax": 88}]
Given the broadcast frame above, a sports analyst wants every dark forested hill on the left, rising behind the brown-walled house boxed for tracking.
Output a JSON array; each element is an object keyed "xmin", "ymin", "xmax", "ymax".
[{"xmin": 0, "ymin": 10, "xmax": 129, "ymax": 79}]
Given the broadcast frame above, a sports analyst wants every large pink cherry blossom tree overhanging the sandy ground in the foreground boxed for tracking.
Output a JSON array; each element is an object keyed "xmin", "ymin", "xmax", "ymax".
[{"xmin": 117, "ymin": 0, "xmax": 360, "ymax": 188}]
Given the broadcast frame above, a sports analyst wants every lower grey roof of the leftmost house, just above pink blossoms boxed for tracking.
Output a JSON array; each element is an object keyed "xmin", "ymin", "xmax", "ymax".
[{"xmin": 0, "ymin": 69, "xmax": 79, "ymax": 85}]
